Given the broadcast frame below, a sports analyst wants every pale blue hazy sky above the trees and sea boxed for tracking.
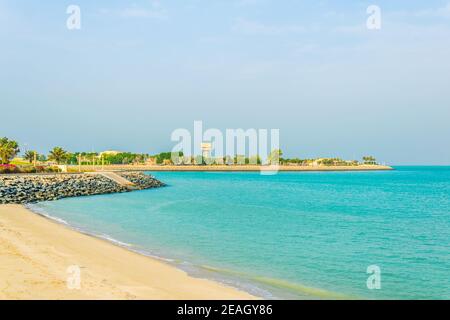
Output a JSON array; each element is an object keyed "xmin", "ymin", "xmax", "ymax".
[{"xmin": 0, "ymin": 0, "xmax": 450, "ymax": 165}]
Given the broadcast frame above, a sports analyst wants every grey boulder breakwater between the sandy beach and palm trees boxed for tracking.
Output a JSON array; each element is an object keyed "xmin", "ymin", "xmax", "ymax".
[{"xmin": 0, "ymin": 172, "xmax": 164, "ymax": 204}]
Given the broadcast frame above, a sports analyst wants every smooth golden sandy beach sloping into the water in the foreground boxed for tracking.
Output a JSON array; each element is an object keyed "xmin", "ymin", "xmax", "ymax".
[{"xmin": 0, "ymin": 205, "xmax": 255, "ymax": 299}]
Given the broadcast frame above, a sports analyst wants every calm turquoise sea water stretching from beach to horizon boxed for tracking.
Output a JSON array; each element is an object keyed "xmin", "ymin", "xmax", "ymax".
[{"xmin": 29, "ymin": 167, "xmax": 450, "ymax": 299}]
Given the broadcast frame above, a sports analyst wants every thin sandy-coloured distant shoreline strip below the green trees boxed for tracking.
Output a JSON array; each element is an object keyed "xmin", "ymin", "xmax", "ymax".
[{"xmin": 68, "ymin": 165, "xmax": 394, "ymax": 172}]
